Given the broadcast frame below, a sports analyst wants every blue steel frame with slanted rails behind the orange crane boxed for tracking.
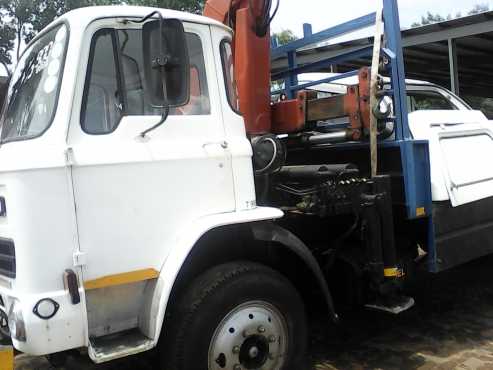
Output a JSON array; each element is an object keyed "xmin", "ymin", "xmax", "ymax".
[{"xmin": 271, "ymin": 0, "xmax": 436, "ymax": 271}]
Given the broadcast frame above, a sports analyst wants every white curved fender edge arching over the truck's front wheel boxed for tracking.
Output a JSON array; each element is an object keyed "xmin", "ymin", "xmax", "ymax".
[{"xmin": 145, "ymin": 207, "xmax": 283, "ymax": 345}]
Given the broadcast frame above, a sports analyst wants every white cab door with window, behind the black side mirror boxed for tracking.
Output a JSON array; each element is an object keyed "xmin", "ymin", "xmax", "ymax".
[{"xmin": 68, "ymin": 20, "xmax": 235, "ymax": 292}]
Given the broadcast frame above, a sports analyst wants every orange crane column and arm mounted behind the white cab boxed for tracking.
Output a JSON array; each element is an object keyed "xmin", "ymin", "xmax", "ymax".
[{"xmin": 204, "ymin": 0, "xmax": 370, "ymax": 140}]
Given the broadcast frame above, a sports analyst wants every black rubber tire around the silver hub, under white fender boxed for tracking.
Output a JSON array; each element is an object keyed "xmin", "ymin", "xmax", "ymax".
[{"xmin": 159, "ymin": 262, "xmax": 307, "ymax": 370}]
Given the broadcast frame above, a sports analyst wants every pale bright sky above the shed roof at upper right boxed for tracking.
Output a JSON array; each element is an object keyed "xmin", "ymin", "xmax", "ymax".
[{"xmin": 272, "ymin": 0, "xmax": 493, "ymax": 36}]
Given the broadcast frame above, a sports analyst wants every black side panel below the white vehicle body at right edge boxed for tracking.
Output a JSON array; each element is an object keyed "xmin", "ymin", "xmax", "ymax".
[{"xmin": 433, "ymin": 197, "xmax": 493, "ymax": 272}]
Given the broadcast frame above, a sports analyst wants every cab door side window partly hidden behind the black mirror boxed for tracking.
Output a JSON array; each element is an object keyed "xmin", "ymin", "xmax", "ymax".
[{"xmin": 81, "ymin": 28, "xmax": 211, "ymax": 134}]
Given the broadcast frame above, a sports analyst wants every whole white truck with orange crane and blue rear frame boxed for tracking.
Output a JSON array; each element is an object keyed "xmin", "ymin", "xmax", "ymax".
[{"xmin": 0, "ymin": 0, "xmax": 493, "ymax": 370}]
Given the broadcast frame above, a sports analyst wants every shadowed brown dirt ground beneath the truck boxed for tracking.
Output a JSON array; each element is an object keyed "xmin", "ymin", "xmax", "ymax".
[{"xmin": 12, "ymin": 257, "xmax": 493, "ymax": 370}]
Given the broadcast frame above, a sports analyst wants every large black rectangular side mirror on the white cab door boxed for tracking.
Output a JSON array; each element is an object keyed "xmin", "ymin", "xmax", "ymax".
[{"xmin": 142, "ymin": 19, "xmax": 190, "ymax": 107}]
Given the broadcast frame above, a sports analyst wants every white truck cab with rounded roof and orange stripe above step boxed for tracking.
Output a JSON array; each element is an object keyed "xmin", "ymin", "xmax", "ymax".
[{"xmin": 0, "ymin": 6, "xmax": 282, "ymax": 362}]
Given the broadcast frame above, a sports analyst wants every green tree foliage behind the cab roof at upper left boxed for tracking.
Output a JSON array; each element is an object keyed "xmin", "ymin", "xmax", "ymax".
[{"xmin": 0, "ymin": 0, "xmax": 205, "ymax": 73}]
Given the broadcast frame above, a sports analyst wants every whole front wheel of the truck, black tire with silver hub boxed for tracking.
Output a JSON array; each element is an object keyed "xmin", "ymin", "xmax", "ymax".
[{"xmin": 161, "ymin": 262, "xmax": 306, "ymax": 370}]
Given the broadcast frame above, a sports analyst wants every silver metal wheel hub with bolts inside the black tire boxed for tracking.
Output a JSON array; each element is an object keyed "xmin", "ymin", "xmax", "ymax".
[{"xmin": 208, "ymin": 301, "xmax": 288, "ymax": 370}]
